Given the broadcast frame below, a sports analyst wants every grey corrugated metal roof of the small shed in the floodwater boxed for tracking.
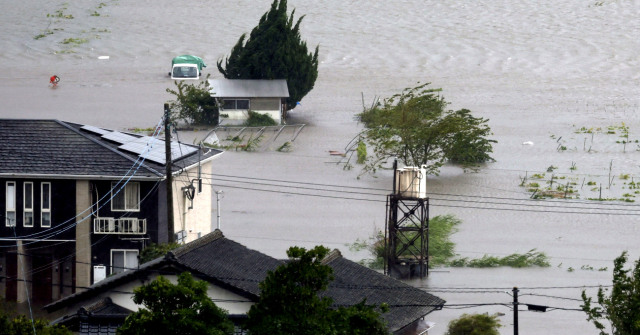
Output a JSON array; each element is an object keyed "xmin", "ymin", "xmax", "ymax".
[{"xmin": 209, "ymin": 79, "xmax": 289, "ymax": 98}]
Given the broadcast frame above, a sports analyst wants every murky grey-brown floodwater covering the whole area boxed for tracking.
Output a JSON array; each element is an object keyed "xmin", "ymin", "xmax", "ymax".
[{"xmin": 0, "ymin": 0, "xmax": 640, "ymax": 335}]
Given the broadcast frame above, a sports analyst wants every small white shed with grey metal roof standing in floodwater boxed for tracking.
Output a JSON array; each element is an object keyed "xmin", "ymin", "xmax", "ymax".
[{"xmin": 209, "ymin": 79, "xmax": 289, "ymax": 125}]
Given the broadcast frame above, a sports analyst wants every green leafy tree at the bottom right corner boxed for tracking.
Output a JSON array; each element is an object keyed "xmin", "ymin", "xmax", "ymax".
[{"xmin": 581, "ymin": 251, "xmax": 640, "ymax": 335}]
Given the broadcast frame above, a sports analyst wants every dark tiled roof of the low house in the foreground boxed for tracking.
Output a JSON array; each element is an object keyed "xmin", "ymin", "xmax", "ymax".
[{"xmin": 45, "ymin": 230, "xmax": 445, "ymax": 331}]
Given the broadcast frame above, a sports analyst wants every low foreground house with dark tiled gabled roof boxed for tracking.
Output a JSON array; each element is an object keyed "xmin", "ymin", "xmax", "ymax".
[{"xmin": 45, "ymin": 230, "xmax": 445, "ymax": 335}]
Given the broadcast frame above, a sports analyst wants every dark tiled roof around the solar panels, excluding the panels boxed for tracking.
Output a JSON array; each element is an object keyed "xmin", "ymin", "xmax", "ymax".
[{"xmin": 0, "ymin": 119, "xmax": 221, "ymax": 179}]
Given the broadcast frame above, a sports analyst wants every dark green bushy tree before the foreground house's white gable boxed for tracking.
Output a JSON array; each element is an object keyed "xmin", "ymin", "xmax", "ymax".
[{"xmin": 118, "ymin": 272, "xmax": 233, "ymax": 335}]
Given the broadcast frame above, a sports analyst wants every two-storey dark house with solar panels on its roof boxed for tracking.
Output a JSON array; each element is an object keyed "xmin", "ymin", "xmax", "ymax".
[{"xmin": 0, "ymin": 119, "xmax": 221, "ymax": 303}]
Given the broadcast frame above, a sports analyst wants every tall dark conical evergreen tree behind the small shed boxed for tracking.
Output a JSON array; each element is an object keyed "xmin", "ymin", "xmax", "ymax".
[{"xmin": 218, "ymin": 0, "xmax": 318, "ymax": 109}]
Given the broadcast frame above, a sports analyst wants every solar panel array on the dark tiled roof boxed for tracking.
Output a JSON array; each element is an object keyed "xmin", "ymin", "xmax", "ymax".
[{"xmin": 81, "ymin": 125, "xmax": 198, "ymax": 165}]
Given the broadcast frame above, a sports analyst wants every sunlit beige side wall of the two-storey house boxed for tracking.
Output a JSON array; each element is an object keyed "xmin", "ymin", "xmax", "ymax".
[{"xmin": 173, "ymin": 161, "xmax": 213, "ymax": 243}]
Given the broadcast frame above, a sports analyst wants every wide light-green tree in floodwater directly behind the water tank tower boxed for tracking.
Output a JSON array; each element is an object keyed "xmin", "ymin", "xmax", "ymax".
[{"xmin": 358, "ymin": 83, "xmax": 496, "ymax": 174}]
